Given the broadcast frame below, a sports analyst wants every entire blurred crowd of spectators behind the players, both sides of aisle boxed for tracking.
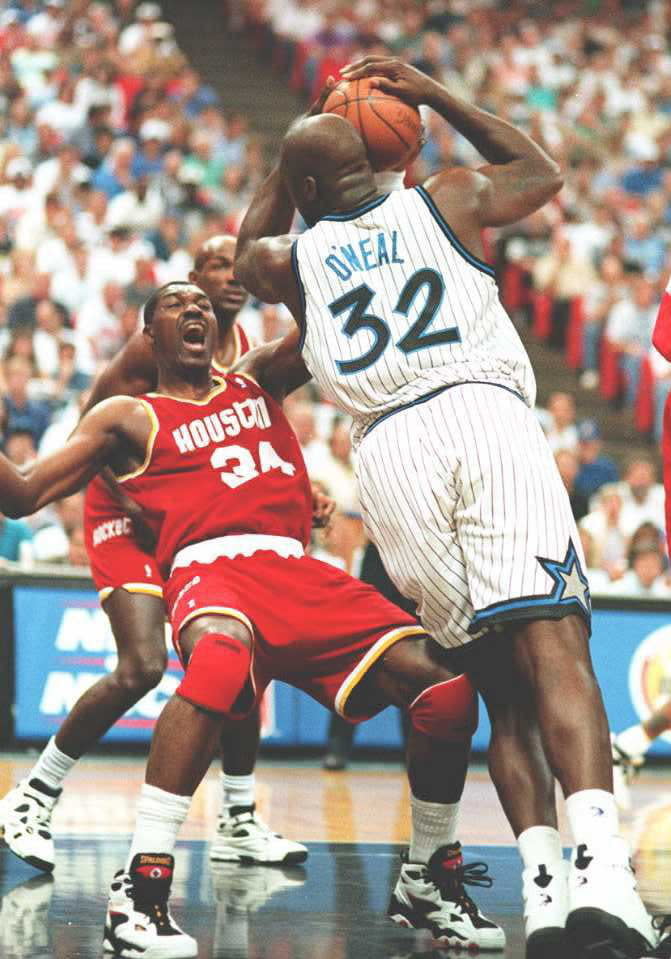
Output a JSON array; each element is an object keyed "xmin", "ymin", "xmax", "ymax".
[{"xmin": 0, "ymin": 0, "xmax": 671, "ymax": 596}]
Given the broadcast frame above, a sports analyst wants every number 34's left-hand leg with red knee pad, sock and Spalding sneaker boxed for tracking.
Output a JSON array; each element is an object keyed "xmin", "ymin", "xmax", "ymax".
[{"xmin": 104, "ymin": 615, "xmax": 254, "ymax": 959}]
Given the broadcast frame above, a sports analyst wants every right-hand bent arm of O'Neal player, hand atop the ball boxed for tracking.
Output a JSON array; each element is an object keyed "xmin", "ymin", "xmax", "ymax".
[{"xmin": 342, "ymin": 56, "xmax": 563, "ymax": 226}]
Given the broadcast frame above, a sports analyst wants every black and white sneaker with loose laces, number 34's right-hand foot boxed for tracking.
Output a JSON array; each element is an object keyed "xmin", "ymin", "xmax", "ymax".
[{"xmin": 387, "ymin": 842, "xmax": 506, "ymax": 951}]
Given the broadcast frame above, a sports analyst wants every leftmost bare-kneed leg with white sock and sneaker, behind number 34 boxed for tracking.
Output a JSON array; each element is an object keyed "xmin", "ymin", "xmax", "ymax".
[{"xmin": 0, "ymin": 589, "xmax": 166, "ymax": 871}]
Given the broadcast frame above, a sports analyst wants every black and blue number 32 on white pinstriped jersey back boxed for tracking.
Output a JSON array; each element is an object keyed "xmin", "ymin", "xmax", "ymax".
[{"xmin": 329, "ymin": 267, "xmax": 461, "ymax": 375}]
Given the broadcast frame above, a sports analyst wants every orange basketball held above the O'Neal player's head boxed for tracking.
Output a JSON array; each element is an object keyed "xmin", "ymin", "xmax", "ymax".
[{"xmin": 323, "ymin": 77, "xmax": 422, "ymax": 170}]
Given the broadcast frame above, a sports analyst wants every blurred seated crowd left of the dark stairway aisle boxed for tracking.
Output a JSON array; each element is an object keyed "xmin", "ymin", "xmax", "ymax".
[{"xmin": 0, "ymin": 0, "xmax": 283, "ymax": 566}]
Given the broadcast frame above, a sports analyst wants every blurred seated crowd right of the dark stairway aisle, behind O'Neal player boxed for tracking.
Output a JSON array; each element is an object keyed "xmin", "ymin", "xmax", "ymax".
[{"xmin": 245, "ymin": 0, "xmax": 671, "ymax": 596}]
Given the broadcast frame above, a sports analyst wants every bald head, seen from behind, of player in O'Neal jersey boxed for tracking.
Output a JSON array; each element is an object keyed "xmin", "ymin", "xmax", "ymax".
[{"xmin": 280, "ymin": 113, "xmax": 375, "ymax": 224}]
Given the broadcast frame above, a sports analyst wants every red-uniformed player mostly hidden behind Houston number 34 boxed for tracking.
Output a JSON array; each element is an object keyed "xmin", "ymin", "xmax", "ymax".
[{"xmin": 0, "ymin": 236, "xmax": 307, "ymax": 871}]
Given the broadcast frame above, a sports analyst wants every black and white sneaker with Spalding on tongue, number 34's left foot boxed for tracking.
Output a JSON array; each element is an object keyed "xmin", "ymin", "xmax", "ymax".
[{"xmin": 103, "ymin": 853, "xmax": 198, "ymax": 959}]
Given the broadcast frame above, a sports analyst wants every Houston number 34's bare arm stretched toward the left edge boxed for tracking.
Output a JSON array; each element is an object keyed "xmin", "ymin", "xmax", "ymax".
[{"xmin": 0, "ymin": 397, "xmax": 151, "ymax": 518}]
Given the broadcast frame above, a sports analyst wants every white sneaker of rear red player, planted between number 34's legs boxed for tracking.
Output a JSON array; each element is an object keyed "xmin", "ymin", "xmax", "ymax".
[{"xmin": 210, "ymin": 806, "xmax": 308, "ymax": 866}]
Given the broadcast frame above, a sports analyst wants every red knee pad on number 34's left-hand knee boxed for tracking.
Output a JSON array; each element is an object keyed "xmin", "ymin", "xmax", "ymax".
[{"xmin": 177, "ymin": 632, "xmax": 251, "ymax": 715}]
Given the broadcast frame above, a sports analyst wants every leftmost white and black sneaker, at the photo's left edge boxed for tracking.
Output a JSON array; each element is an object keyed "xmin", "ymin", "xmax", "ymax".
[{"xmin": 0, "ymin": 779, "xmax": 61, "ymax": 872}]
